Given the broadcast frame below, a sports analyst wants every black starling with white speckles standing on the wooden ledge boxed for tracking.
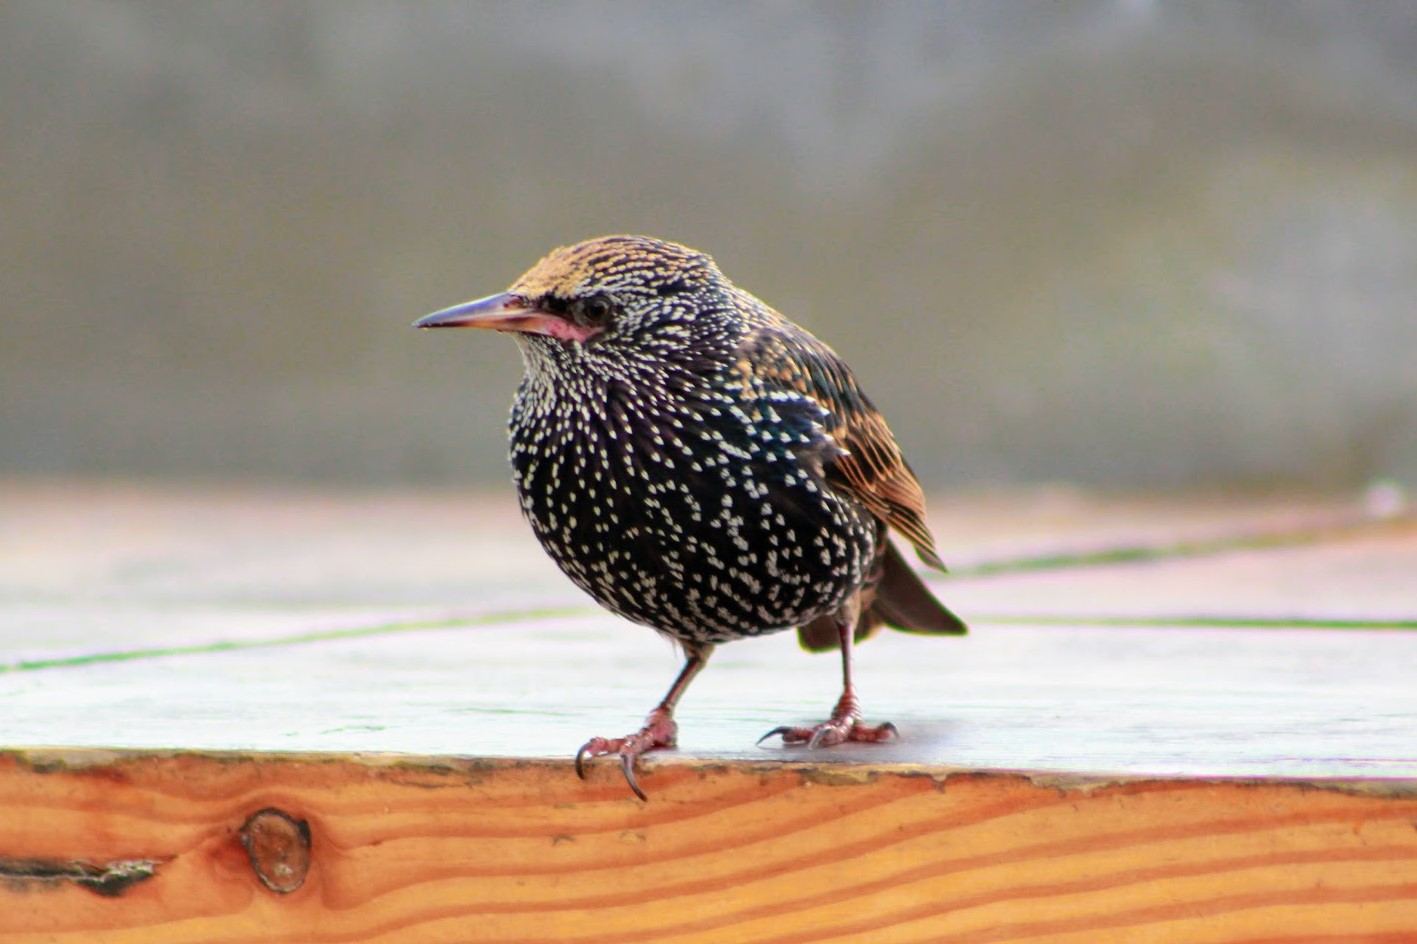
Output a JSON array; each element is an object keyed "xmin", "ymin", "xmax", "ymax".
[{"xmin": 414, "ymin": 235, "xmax": 966, "ymax": 801}]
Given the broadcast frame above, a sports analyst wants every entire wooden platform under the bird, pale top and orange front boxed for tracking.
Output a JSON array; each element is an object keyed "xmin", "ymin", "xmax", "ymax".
[{"xmin": 0, "ymin": 482, "xmax": 1417, "ymax": 944}]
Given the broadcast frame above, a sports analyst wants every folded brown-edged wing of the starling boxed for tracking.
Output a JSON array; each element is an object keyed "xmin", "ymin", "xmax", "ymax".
[{"xmin": 740, "ymin": 322, "xmax": 945, "ymax": 570}]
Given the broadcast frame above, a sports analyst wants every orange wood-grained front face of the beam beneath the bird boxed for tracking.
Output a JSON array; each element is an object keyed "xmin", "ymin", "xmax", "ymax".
[{"xmin": 0, "ymin": 751, "xmax": 1417, "ymax": 944}]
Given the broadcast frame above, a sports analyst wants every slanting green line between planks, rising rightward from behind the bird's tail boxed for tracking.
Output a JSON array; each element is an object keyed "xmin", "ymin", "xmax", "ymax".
[{"xmin": 949, "ymin": 516, "xmax": 1417, "ymax": 577}]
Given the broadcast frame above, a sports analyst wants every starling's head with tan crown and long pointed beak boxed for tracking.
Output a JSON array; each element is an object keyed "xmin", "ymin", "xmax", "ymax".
[{"xmin": 414, "ymin": 235, "xmax": 728, "ymax": 363}]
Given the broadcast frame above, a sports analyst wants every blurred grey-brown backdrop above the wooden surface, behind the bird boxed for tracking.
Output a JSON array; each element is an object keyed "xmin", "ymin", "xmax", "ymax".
[{"xmin": 0, "ymin": 7, "xmax": 1417, "ymax": 488}]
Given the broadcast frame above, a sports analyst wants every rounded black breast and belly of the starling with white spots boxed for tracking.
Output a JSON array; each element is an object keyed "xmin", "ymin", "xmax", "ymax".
[{"xmin": 510, "ymin": 388, "xmax": 879, "ymax": 642}]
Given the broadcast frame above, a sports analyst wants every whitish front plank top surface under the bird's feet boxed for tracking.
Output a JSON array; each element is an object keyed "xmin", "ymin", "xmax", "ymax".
[{"xmin": 0, "ymin": 614, "xmax": 1417, "ymax": 777}]
